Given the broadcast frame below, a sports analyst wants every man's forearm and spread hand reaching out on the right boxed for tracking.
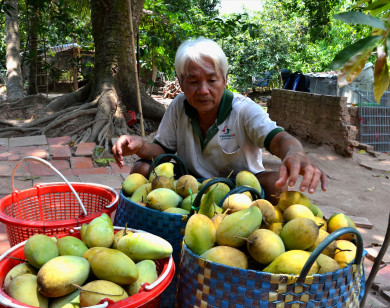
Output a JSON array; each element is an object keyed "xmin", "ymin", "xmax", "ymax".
[{"xmin": 270, "ymin": 131, "xmax": 328, "ymax": 194}]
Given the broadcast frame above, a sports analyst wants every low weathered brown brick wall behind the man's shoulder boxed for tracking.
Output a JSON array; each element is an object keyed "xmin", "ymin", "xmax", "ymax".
[{"xmin": 268, "ymin": 89, "xmax": 359, "ymax": 156}]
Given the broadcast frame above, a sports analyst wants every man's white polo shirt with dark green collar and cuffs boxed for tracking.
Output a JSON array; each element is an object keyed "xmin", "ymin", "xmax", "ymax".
[{"xmin": 155, "ymin": 90, "xmax": 283, "ymax": 178}]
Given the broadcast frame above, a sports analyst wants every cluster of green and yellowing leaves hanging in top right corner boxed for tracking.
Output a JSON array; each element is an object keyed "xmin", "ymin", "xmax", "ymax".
[{"xmin": 330, "ymin": 0, "xmax": 390, "ymax": 103}]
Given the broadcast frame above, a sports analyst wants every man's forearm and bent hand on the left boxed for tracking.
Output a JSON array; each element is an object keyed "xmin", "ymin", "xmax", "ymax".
[{"xmin": 112, "ymin": 135, "xmax": 165, "ymax": 168}]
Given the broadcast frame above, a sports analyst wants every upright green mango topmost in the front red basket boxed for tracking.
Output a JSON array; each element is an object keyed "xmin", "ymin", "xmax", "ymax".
[{"xmin": 81, "ymin": 213, "xmax": 114, "ymax": 248}]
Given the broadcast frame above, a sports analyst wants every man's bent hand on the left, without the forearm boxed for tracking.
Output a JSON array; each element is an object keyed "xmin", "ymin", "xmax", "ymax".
[{"xmin": 112, "ymin": 135, "xmax": 145, "ymax": 168}]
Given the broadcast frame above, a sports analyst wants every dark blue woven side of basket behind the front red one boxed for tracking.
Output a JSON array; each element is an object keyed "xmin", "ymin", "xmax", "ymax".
[{"xmin": 114, "ymin": 191, "xmax": 188, "ymax": 307}]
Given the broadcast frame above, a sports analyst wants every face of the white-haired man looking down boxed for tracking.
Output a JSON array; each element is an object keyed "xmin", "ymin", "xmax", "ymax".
[{"xmin": 180, "ymin": 58, "xmax": 227, "ymax": 114}]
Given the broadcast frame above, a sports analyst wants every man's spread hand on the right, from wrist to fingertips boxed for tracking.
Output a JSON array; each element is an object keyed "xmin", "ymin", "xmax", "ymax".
[{"xmin": 275, "ymin": 154, "xmax": 328, "ymax": 194}]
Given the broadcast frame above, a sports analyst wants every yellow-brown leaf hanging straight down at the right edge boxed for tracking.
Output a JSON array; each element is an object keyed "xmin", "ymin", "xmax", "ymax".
[{"xmin": 374, "ymin": 47, "xmax": 389, "ymax": 104}]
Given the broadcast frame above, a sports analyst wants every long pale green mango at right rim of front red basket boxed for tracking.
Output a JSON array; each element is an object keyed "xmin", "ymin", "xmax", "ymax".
[{"xmin": 117, "ymin": 232, "xmax": 173, "ymax": 262}]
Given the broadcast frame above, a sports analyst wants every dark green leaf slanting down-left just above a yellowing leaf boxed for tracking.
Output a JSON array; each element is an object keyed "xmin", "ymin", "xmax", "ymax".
[{"xmin": 329, "ymin": 35, "xmax": 382, "ymax": 69}]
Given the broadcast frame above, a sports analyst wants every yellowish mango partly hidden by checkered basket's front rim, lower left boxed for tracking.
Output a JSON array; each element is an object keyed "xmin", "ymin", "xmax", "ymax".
[{"xmin": 200, "ymin": 246, "xmax": 248, "ymax": 269}]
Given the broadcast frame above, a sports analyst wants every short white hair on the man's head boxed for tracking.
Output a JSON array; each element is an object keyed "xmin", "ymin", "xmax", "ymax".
[{"xmin": 175, "ymin": 37, "xmax": 229, "ymax": 81}]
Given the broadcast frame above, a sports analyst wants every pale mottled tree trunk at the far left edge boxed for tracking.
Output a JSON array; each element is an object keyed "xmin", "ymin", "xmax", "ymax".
[{"xmin": 4, "ymin": 0, "xmax": 24, "ymax": 100}]
